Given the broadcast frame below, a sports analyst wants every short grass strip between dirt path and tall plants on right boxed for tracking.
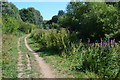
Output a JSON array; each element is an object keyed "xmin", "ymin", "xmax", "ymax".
[{"xmin": 27, "ymin": 35, "xmax": 98, "ymax": 78}]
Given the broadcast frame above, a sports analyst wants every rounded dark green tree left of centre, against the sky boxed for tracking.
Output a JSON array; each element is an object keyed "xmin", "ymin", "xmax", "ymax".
[{"xmin": 20, "ymin": 7, "xmax": 43, "ymax": 26}]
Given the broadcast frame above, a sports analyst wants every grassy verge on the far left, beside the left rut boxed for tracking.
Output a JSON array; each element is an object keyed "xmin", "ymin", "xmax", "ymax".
[{"xmin": 2, "ymin": 34, "xmax": 19, "ymax": 78}]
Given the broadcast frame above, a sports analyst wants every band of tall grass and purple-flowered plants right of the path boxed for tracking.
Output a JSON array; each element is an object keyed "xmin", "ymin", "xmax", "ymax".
[{"xmin": 31, "ymin": 29, "xmax": 120, "ymax": 78}]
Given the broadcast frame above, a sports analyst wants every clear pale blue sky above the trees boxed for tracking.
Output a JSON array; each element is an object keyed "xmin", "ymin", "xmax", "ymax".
[{"xmin": 12, "ymin": 2, "xmax": 68, "ymax": 20}]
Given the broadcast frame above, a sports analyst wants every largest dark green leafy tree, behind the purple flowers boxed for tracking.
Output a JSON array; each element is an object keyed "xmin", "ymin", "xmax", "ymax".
[{"xmin": 59, "ymin": 2, "xmax": 118, "ymax": 39}]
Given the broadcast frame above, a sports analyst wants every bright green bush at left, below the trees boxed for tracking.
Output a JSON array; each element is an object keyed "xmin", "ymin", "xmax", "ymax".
[{"xmin": 2, "ymin": 16, "xmax": 36, "ymax": 34}]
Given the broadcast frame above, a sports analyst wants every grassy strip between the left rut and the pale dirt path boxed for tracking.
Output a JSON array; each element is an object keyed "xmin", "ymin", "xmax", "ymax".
[{"xmin": 20, "ymin": 35, "xmax": 41, "ymax": 78}]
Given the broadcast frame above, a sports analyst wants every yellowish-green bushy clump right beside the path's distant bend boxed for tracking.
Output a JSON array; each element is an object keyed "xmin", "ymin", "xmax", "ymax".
[{"xmin": 31, "ymin": 29, "xmax": 70, "ymax": 52}]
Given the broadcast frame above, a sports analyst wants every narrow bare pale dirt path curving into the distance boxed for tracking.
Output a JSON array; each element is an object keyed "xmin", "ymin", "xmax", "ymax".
[{"xmin": 24, "ymin": 34, "xmax": 55, "ymax": 78}]
